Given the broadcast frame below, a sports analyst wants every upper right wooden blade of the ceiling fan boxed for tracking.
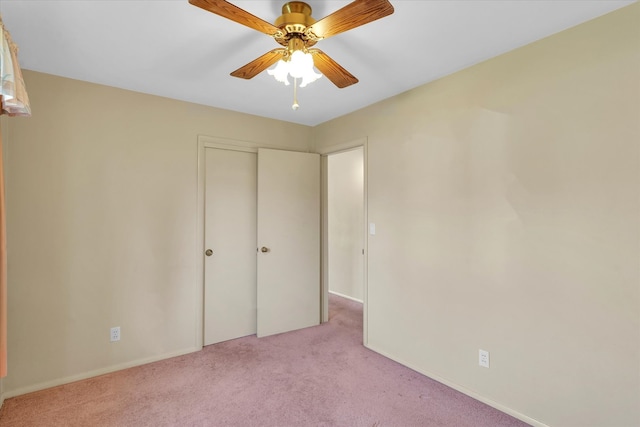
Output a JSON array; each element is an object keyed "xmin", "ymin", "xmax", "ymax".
[{"xmin": 307, "ymin": 0, "xmax": 393, "ymax": 39}]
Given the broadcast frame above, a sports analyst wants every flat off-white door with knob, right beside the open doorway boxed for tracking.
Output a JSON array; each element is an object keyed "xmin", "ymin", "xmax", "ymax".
[{"xmin": 257, "ymin": 149, "xmax": 320, "ymax": 337}]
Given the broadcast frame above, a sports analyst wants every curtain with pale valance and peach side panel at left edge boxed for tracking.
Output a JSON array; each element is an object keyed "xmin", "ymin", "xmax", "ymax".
[{"xmin": 0, "ymin": 17, "xmax": 31, "ymax": 378}]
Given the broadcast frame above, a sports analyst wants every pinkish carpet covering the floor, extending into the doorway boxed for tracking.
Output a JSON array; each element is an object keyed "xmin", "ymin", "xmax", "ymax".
[{"xmin": 0, "ymin": 295, "xmax": 526, "ymax": 427}]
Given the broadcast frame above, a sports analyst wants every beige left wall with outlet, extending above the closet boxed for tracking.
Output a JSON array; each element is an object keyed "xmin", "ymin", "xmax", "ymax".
[{"xmin": 3, "ymin": 71, "xmax": 311, "ymax": 395}]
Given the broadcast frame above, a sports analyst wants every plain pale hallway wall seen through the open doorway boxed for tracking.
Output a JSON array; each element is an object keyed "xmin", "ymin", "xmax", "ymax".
[{"xmin": 327, "ymin": 147, "xmax": 364, "ymax": 301}]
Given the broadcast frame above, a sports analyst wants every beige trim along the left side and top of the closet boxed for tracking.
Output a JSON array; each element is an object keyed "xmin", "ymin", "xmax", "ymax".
[{"xmin": 195, "ymin": 135, "xmax": 312, "ymax": 350}]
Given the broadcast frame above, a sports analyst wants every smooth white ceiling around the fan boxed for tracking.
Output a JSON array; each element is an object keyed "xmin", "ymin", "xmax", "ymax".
[{"xmin": 0, "ymin": 0, "xmax": 634, "ymax": 126}]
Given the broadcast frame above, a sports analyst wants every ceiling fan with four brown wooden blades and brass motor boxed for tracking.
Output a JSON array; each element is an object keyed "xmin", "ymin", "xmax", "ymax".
[{"xmin": 189, "ymin": 0, "xmax": 393, "ymax": 88}]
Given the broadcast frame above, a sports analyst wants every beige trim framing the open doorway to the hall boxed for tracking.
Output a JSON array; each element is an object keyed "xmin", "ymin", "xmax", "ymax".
[{"xmin": 316, "ymin": 136, "xmax": 369, "ymax": 346}]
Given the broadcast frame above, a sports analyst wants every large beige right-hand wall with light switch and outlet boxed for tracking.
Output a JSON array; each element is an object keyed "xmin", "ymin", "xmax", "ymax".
[{"xmin": 314, "ymin": 4, "xmax": 640, "ymax": 427}]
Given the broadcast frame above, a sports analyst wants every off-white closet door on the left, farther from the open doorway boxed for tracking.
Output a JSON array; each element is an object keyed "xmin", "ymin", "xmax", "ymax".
[{"xmin": 204, "ymin": 148, "xmax": 257, "ymax": 345}]
